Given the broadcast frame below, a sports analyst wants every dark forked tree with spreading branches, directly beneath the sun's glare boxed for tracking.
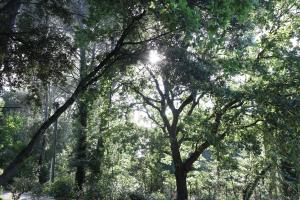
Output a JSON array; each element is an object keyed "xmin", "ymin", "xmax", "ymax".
[{"xmin": 127, "ymin": 46, "xmax": 243, "ymax": 199}]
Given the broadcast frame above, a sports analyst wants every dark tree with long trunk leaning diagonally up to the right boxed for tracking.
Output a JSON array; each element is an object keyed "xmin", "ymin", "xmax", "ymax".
[{"xmin": 0, "ymin": 2, "xmax": 191, "ymax": 184}]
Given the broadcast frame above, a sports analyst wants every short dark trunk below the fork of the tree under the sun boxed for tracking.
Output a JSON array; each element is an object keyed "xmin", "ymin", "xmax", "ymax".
[{"xmin": 175, "ymin": 167, "xmax": 188, "ymax": 200}]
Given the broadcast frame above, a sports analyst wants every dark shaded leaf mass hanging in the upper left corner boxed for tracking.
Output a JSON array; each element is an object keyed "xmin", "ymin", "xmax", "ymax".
[{"xmin": 0, "ymin": 0, "xmax": 75, "ymax": 92}]
